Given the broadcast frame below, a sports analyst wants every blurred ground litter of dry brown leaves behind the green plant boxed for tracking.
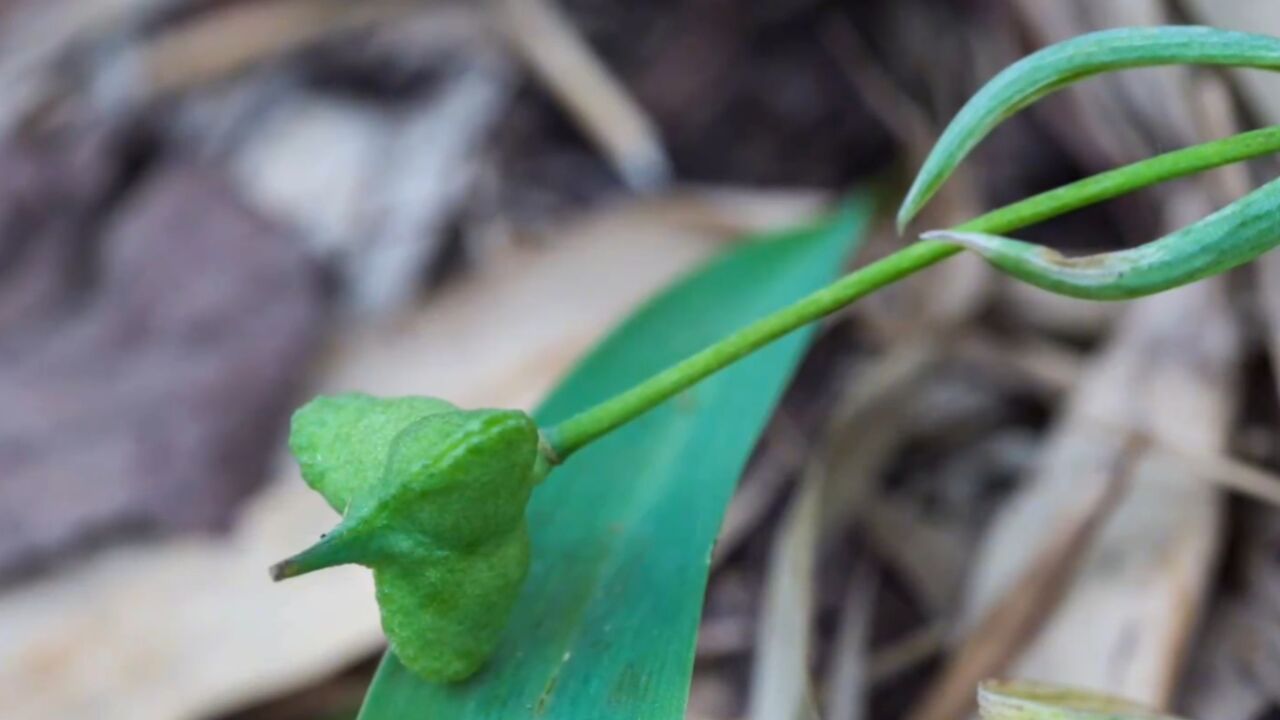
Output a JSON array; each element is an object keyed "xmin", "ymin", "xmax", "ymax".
[{"xmin": 0, "ymin": 0, "xmax": 1280, "ymax": 720}]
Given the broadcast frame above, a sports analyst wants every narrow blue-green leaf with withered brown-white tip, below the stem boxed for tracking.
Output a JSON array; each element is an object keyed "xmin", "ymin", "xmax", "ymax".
[{"xmin": 922, "ymin": 174, "xmax": 1280, "ymax": 300}]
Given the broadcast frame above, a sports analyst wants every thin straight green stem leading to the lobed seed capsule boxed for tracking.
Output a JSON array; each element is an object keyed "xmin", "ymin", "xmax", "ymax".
[{"xmin": 544, "ymin": 126, "xmax": 1280, "ymax": 462}]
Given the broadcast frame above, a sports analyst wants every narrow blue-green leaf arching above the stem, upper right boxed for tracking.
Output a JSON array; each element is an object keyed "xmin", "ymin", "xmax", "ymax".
[{"xmin": 897, "ymin": 26, "xmax": 1280, "ymax": 229}]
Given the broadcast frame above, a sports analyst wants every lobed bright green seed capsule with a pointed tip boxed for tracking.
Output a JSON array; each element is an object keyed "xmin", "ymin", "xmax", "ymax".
[{"xmin": 273, "ymin": 395, "xmax": 545, "ymax": 682}]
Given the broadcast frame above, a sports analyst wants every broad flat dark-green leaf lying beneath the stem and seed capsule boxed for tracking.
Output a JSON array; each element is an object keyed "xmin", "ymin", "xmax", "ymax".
[{"xmin": 360, "ymin": 193, "xmax": 870, "ymax": 720}]
